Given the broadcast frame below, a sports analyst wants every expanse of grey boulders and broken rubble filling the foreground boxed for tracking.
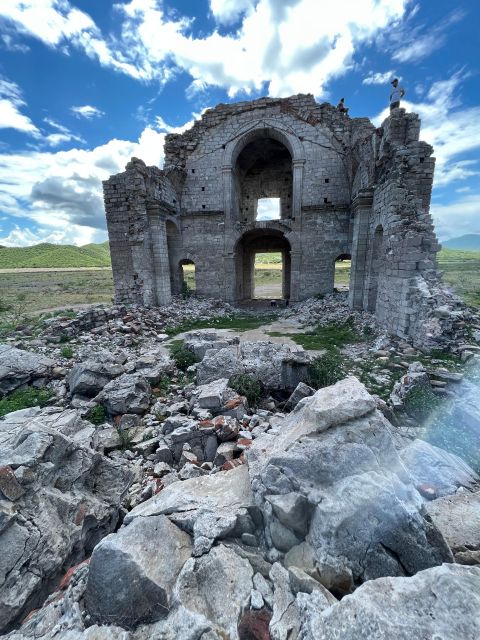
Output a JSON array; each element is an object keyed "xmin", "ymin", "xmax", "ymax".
[{"xmin": 0, "ymin": 302, "xmax": 480, "ymax": 640}]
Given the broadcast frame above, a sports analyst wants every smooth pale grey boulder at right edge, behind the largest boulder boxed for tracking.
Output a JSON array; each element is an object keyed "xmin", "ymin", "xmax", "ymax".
[{"xmin": 400, "ymin": 440, "xmax": 480, "ymax": 497}]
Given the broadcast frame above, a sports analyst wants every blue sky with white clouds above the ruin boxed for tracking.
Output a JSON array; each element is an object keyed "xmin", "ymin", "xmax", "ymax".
[{"xmin": 0, "ymin": 0, "xmax": 480, "ymax": 246}]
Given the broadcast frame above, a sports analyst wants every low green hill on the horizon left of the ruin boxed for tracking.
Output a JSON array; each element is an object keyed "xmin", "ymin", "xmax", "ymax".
[{"xmin": 0, "ymin": 242, "xmax": 111, "ymax": 269}]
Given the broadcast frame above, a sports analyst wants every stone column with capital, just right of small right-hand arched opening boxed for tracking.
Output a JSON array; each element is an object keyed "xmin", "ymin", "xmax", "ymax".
[{"xmin": 348, "ymin": 189, "xmax": 373, "ymax": 309}]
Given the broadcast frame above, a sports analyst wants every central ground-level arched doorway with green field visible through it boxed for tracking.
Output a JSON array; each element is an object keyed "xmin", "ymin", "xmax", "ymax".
[{"xmin": 235, "ymin": 229, "xmax": 291, "ymax": 301}]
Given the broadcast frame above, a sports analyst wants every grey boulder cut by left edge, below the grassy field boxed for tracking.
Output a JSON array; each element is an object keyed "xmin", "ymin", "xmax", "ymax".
[{"xmin": 0, "ymin": 344, "xmax": 55, "ymax": 398}]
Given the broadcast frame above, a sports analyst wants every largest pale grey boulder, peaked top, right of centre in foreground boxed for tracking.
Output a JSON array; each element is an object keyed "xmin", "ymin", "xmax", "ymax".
[{"xmin": 247, "ymin": 377, "xmax": 452, "ymax": 594}]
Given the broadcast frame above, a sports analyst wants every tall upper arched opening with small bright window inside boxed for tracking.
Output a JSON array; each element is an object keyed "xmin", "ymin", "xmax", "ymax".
[{"xmin": 234, "ymin": 136, "xmax": 293, "ymax": 223}]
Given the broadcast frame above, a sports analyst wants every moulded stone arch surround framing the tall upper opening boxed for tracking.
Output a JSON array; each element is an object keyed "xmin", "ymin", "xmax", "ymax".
[{"xmin": 223, "ymin": 120, "xmax": 305, "ymax": 224}]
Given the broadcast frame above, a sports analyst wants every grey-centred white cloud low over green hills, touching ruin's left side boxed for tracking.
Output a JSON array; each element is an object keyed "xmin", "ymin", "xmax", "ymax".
[{"xmin": 0, "ymin": 125, "xmax": 169, "ymax": 244}]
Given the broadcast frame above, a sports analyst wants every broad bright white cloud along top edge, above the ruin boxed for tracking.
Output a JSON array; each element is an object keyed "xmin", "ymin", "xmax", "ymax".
[{"xmin": 0, "ymin": 0, "xmax": 411, "ymax": 96}]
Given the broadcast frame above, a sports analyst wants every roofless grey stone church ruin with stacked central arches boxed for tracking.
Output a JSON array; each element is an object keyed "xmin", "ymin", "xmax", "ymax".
[{"xmin": 104, "ymin": 95, "xmax": 439, "ymax": 337}]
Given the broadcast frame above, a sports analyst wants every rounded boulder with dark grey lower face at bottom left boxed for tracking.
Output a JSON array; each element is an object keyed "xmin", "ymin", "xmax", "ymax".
[{"xmin": 85, "ymin": 515, "xmax": 192, "ymax": 629}]
